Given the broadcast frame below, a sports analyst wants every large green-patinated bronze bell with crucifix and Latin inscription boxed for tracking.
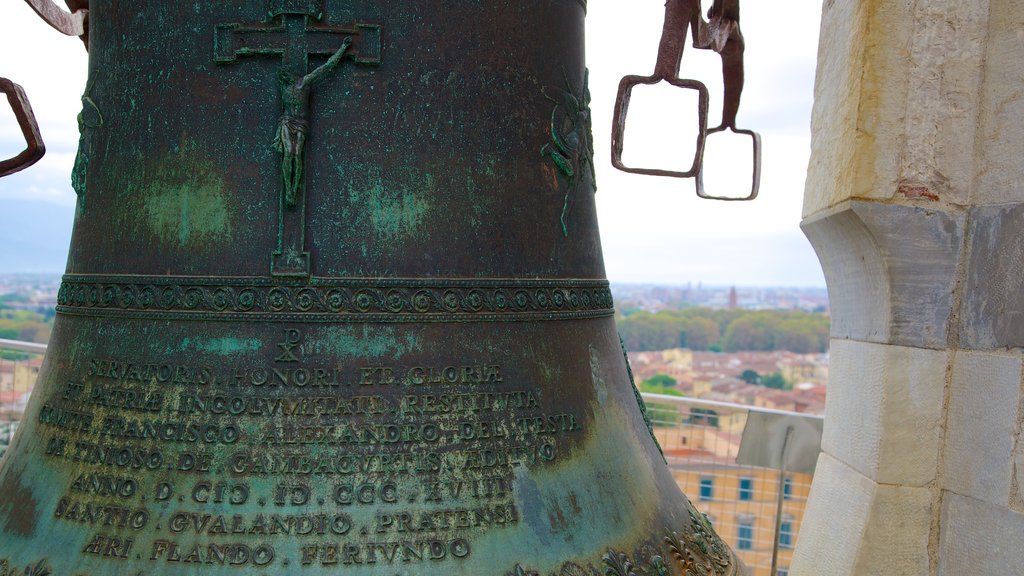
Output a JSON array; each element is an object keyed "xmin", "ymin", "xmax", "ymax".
[{"xmin": 0, "ymin": 0, "xmax": 741, "ymax": 576}]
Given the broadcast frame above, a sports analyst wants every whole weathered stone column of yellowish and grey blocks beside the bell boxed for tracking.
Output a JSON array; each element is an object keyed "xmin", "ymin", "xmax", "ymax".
[{"xmin": 791, "ymin": 0, "xmax": 1024, "ymax": 576}]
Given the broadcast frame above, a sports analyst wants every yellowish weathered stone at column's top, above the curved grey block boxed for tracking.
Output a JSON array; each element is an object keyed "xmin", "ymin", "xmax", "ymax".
[{"xmin": 804, "ymin": 0, "xmax": 988, "ymax": 217}]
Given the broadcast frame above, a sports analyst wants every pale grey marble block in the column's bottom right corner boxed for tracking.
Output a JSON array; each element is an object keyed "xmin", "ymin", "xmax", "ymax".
[{"xmin": 938, "ymin": 493, "xmax": 1024, "ymax": 576}]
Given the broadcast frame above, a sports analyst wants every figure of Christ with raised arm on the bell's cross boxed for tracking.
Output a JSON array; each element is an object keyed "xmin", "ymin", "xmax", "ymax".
[{"xmin": 273, "ymin": 38, "xmax": 352, "ymax": 209}]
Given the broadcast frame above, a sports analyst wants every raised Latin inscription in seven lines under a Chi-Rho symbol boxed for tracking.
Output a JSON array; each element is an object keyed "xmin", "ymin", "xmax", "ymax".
[{"xmin": 36, "ymin": 329, "xmax": 584, "ymax": 568}]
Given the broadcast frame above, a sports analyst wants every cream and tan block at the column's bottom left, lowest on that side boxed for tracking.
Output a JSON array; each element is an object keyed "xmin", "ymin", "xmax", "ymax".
[{"xmin": 791, "ymin": 454, "xmax": 932, "ymax": 576}]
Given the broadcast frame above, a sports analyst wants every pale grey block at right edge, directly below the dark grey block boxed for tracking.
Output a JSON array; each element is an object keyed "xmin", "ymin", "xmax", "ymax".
[{"xmin": 942, "ymin": 351, "xmax": 1021, "ymax": 506}]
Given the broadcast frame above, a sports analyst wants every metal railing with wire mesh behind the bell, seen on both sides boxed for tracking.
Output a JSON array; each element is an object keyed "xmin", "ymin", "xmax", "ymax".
[{"xmin": 0, "ymin": 339, "xmax": 821, "ymax": 576}]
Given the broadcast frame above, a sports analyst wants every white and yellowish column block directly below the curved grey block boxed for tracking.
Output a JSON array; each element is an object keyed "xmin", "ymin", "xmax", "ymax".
[{"xmin": 821, "ymin": 339, "xmax": 948, "ymax": 487}]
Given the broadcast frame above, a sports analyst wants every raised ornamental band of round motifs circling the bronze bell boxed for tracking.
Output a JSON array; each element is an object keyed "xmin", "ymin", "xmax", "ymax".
[{"xmin": 56, "ymin": 275, "xmax": 614, "ymax": 322}]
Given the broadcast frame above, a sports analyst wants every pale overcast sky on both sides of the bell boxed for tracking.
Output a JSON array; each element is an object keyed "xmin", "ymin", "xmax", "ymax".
[{"xmin": 0, "ymin": 0, "xmax": 824, "ymax": 286}]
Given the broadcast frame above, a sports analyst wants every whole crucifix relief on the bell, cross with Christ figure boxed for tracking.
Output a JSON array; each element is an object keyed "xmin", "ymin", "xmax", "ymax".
[{"xmin": 214, "ymin": 0, "xmax": 381, "ymax": 278}]
